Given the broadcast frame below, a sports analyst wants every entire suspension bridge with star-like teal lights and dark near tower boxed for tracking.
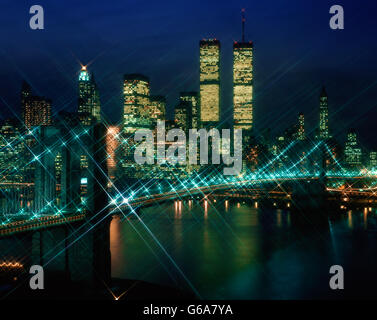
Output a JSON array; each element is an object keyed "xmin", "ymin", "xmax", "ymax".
[{"xmin": 0, "ymin": 124, "xmax": 377, "ymax": 296}]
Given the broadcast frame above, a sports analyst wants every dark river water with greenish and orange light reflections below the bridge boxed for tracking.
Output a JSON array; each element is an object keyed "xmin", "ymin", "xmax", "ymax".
[{"xmin": 110, "ymin": 200, "xmax": 377, "ymax": 299}]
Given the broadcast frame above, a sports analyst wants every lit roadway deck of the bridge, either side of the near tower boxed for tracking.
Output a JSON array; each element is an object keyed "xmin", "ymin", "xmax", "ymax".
[{"xmin": 0, "ymin": 175, "xmax": 377, "ymax": 236}]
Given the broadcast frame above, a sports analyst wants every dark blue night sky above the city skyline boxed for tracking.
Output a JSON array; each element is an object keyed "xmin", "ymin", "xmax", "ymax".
[{"xmin": 0, "ymin": 0, "xmax": 377, "ymax": 149}]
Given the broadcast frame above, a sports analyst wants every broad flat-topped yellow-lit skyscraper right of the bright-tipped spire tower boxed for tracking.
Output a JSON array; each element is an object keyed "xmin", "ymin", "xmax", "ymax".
[{"xmin": 123, "ymin": 74, "xmax": 151, "ymax": 133}]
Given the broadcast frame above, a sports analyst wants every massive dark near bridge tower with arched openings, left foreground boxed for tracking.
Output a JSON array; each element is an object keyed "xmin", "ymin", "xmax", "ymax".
[{"xmin": 32, "ymin": 122, "xmax": 111, "ymax": 286}]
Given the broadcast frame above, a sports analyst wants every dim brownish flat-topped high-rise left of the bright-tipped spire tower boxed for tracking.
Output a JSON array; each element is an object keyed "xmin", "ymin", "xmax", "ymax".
[{"xmin": 23, "ymin": 95, "xmax": 52, "ymax": 129}]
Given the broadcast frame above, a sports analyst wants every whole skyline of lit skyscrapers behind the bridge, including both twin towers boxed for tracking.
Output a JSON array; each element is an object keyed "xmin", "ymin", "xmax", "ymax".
[{"xmin": 0, "ymin": 11, "xmax": 377, "ymax": 185}]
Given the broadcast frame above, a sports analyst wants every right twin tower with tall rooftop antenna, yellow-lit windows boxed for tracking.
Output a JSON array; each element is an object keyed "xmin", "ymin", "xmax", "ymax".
[{"xmin": 233, "ymin": 10, "xmax": 253, "ymax": 130}]
